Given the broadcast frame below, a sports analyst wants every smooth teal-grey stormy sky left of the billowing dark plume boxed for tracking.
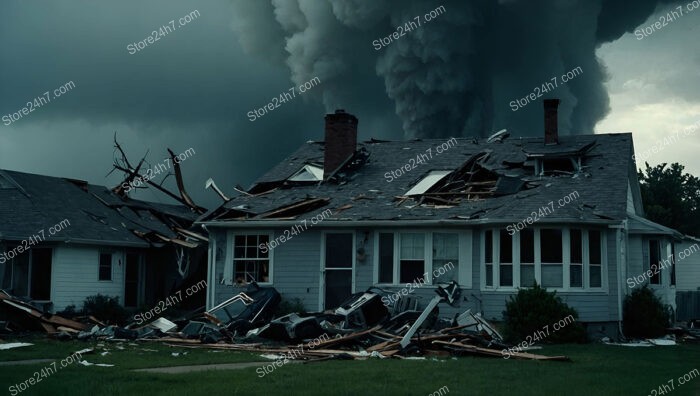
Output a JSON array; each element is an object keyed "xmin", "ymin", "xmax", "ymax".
[{"xmin": 0, "ymin": 1, "xmax": 388, "ymax": 204}]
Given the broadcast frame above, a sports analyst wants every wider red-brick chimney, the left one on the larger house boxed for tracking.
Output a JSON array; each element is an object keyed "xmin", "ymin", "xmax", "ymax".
[{"xmin": 323, "ymin": 109, "xmax": 357, "ymax": 180}]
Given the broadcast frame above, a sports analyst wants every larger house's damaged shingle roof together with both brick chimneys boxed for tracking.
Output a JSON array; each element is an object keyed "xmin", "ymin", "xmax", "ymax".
[{"xmin": 200, "ymin": 103, "xmax": 641, "ymax": 224}]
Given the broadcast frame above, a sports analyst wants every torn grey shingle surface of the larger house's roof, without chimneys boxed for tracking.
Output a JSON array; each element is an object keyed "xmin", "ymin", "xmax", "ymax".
[{"xmin": 200, "ymin": 133, "xmax": 634, "ymax": 224}]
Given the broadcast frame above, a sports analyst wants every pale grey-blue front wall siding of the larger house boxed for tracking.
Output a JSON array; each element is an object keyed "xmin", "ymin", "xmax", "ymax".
[{"xmin": 210, "ymin": 223, "xmax": 628, "ymax": 322}]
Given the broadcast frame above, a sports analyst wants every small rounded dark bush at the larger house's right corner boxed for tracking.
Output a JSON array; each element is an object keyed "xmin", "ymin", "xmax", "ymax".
[{"xmin": 622, "ymin": 285, "xmax": 670, "ymax": 338}]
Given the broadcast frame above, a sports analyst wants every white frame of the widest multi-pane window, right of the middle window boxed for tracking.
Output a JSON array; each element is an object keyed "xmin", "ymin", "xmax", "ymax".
[{"xmin": 479, "ymin": 225, "xmax": 608, "ymax": 293}]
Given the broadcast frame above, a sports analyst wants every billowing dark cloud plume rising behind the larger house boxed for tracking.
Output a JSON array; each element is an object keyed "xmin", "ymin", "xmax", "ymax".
[{"xmin": 234, "ymin": 0, "xmax": 680, "ymax": 137}]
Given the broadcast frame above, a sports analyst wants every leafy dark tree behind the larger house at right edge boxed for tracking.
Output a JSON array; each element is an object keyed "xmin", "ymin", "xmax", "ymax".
[{"xmin": 638, "ymin": 162, "xmax": 700, "ymax": 236}]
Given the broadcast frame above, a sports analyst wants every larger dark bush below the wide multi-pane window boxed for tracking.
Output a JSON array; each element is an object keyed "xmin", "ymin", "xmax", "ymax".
[{"xmin": 503, "ymin": 283, "xmax": 586, "ymax": 343}]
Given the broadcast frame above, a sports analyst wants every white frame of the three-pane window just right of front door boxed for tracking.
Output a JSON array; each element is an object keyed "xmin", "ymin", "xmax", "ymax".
[{"xmin": 373, "ymin": 229, "xmax": 474, "ymax": 289}]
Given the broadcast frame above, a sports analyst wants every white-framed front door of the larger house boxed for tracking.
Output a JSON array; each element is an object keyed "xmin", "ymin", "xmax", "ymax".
[{"xmin": 323, "ymin": 232, "xmax": 354, "ymax": 309}]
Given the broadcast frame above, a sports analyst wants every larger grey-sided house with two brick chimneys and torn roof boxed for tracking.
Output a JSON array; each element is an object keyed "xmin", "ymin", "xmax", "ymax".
[{"xmin": 198, "ymin": 100, "xmax": 700, "ymax": 335}]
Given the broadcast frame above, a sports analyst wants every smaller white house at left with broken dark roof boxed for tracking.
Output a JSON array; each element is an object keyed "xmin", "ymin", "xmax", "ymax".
[{"xmin": 0, "ymin": 170, "xmax": 207, "ymax": 312}]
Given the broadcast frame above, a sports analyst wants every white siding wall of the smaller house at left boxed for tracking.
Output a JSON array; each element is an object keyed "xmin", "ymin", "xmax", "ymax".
[{"xmin": 51, "ymin": 246, "xmax": 124, "ymax": 311}]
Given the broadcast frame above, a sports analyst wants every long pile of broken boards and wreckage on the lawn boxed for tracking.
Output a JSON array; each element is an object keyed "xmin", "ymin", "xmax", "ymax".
[{"xmin": 0, "ymin": 281, "xmax": 569, "ymax": 361}]
